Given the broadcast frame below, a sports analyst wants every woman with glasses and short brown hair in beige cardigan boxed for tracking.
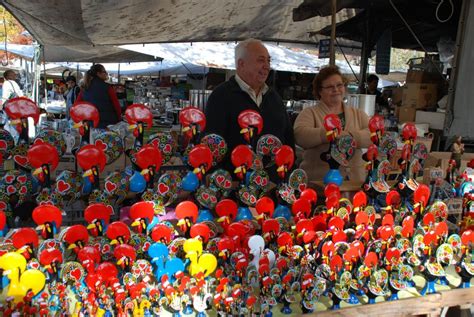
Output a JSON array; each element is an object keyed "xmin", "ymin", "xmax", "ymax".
[{"xmin": 294, "ymin": 66, "xmax": 370, "ymax": 181}]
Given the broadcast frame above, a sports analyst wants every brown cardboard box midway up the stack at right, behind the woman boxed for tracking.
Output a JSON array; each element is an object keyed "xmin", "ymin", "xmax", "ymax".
[{"xmin": 402, "ymin": 84, "xmax": 438, "ymax": 109}]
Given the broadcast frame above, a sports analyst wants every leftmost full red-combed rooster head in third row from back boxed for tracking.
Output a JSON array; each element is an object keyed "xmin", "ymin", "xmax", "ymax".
[{"xmin": 32, "ymin": 205, "xmax": 63, "ymax": 239}]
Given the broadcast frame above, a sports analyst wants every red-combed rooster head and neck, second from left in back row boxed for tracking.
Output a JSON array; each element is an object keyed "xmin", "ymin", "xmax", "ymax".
[{"xmin": 69, "ymin": 101, "xmax": 99, "ymax": 145}]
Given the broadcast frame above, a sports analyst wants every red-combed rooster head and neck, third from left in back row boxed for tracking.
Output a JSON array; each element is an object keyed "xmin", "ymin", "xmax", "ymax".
[{"xmin": 125, "ymin": 103, "xmax": 153, "ymax": 149}]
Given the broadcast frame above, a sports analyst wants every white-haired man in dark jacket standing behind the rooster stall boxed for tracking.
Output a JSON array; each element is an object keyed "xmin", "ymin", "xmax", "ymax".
[{"xmin": 205, "ymin": 39, "xmax": 294, "ymax": 177}]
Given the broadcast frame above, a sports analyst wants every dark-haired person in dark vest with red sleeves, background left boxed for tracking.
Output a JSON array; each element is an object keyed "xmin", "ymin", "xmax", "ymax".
[{"xmin": 76, "ymin": 64, "xmax": 122, "ymax": 129}]
